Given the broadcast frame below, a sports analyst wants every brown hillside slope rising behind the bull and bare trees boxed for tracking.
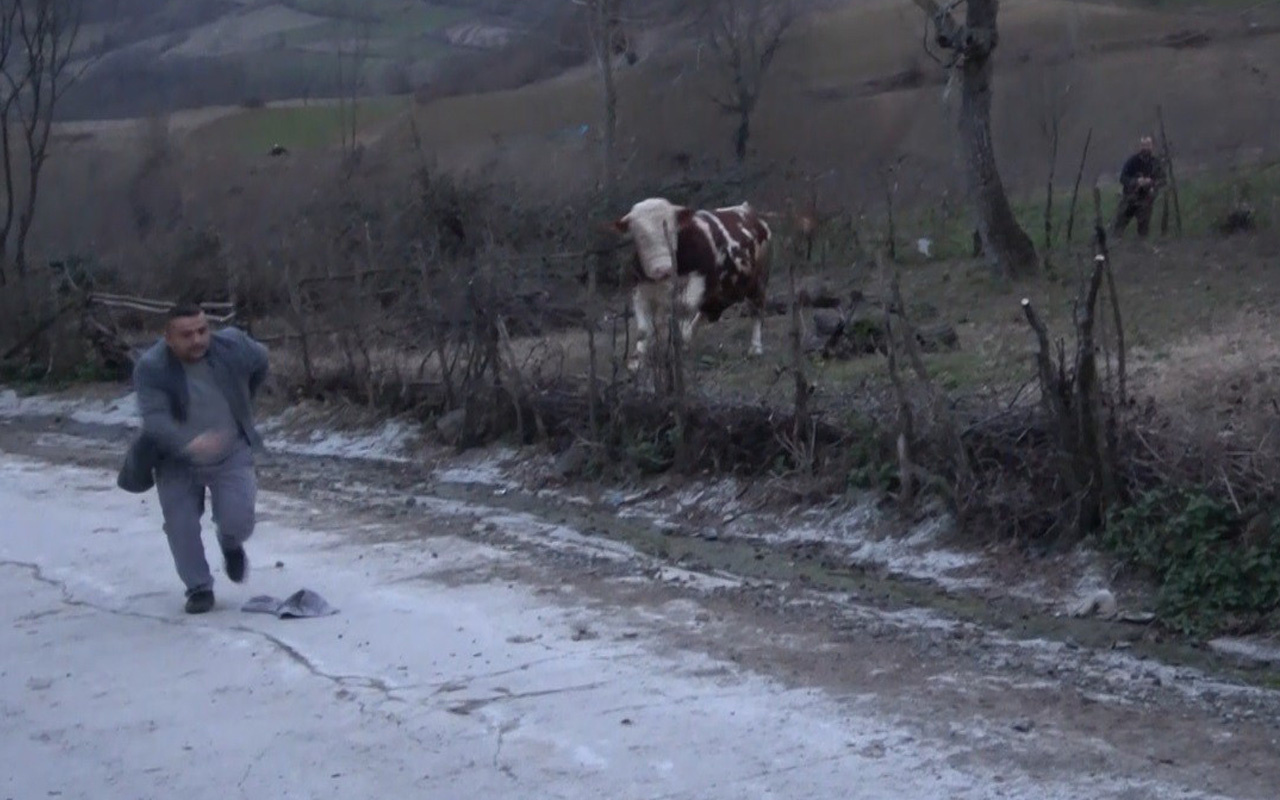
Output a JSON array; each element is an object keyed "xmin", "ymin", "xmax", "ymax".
[{"xmin": 390, "ymin": 0, "xmax": 1280, "ymax": 207}]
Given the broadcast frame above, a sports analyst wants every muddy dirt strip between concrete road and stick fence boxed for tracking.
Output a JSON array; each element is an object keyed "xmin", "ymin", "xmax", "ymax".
[{"xmin": 0, "ymin": 401, "xmax": 1280, "ymax": 797}]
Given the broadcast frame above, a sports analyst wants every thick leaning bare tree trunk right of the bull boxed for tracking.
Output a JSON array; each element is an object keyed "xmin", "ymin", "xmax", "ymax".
[{"xmin": 913, "ymin": 0, "xmax": 1039, "ymax": 278}]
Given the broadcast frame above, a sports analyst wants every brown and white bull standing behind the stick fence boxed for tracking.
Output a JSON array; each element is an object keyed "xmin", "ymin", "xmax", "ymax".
[{"xmin": 613, "ymin": 197, "xmax": 772, "ymax": 370}]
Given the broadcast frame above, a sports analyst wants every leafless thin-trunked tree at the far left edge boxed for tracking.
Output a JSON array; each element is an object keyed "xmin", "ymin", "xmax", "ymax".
[{"xmin": 0, "ymin": 0, "xmax": 87, "ymax": 285}]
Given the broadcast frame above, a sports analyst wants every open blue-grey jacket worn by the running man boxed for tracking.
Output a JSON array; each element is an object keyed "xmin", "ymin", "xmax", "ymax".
[{"xmin": 116, "ymin": 328, "xmax": 268, "ymax": 493}]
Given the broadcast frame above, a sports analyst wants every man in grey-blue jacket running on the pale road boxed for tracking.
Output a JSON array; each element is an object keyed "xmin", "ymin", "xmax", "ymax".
[{"xmin": 120, "ymin": 305, "xmax": 268, "ymax": 614}]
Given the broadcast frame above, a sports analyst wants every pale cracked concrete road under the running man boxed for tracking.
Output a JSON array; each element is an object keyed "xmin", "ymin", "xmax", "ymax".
[{"xmin": 0, "ymin": 453, "xmax": 1259, "ymax": 800}]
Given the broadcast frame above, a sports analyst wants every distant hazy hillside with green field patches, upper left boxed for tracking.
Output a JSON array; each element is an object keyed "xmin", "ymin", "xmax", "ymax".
[{"xmin": 61, "ymin": 0, "xmax": 586, "ymax": 119}]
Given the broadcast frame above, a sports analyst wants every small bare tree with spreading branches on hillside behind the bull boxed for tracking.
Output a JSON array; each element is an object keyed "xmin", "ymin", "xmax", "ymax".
[{"xmin": 696, "ymin": 0, "xmax": 799, "ymax": 164}]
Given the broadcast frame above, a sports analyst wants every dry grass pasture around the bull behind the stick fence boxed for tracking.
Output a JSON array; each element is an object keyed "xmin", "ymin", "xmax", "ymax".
[{"xmin": 360, "ymin": 225, "xmax": 1280, "ymax": 440}]
